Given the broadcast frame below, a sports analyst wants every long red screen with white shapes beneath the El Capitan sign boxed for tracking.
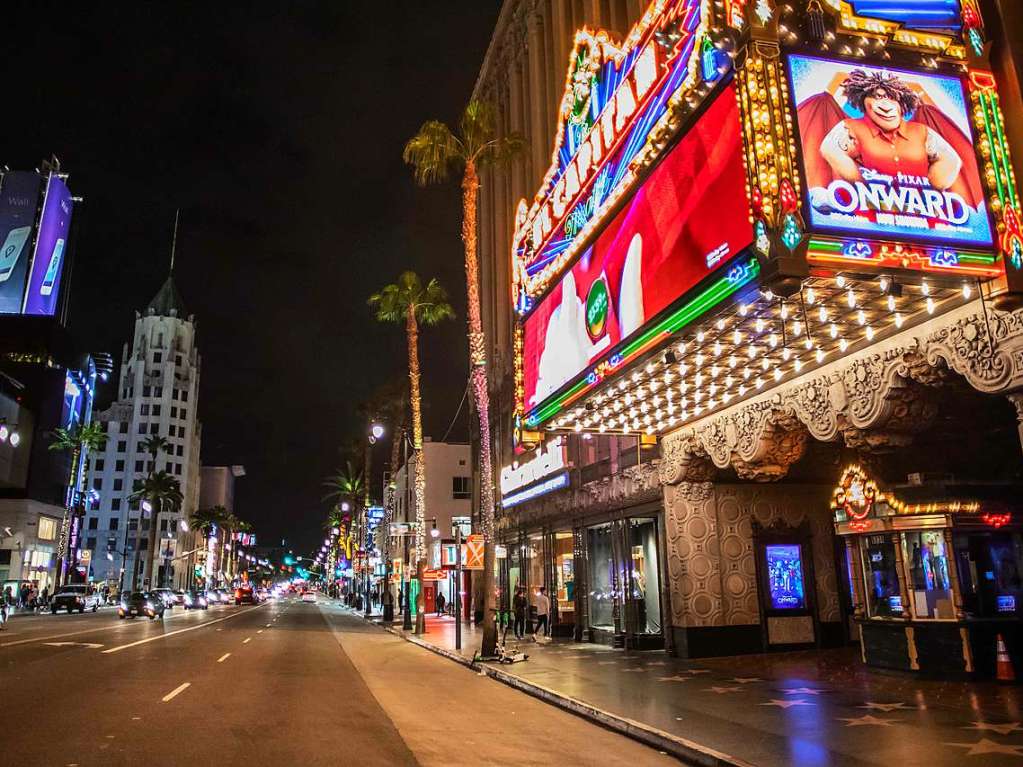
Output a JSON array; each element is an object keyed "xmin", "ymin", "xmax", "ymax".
[{"xmin": 523, "ymin": 85, "xmax": 753, "ymax": 409}]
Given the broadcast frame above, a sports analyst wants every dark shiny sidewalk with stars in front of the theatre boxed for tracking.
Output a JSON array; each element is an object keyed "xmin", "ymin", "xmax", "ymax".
[{"xmin": 362, "ymin": 616, "xmax": 1023, "ymax": 767}]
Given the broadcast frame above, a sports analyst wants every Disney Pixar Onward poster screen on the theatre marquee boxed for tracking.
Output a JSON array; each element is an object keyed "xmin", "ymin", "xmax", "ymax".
[{"xmin": 789, "ymin": 55, "xmax": 993, "ymax": 247}]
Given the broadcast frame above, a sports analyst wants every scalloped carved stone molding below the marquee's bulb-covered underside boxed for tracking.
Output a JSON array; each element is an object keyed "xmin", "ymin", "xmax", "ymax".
[{"xmin": 660, "ymin": 300, "xmax": 1023, "ymax": 484}]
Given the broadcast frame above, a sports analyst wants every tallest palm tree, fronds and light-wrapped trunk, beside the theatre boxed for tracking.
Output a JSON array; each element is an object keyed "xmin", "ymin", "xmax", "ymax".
[{"xmin": 404, "ymin": 101, "xmax": 526, "ymax": 656}]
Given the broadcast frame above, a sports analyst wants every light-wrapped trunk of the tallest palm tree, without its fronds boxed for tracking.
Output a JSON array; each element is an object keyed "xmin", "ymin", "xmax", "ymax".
[{"xmin": 461, "ymin": 161, "xmax": 497, "ymax": 657}]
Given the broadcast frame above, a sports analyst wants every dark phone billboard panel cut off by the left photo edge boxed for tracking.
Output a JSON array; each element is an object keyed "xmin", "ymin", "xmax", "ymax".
[{"xmin": 0, "ymin": 171, "xmax": 42, "ymax": 314}]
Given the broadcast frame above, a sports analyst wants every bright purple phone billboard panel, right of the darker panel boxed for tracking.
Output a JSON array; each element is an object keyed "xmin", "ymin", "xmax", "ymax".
[{"xmin": 25, "ymin": 174, "xmax": 73, "ymax": 315}]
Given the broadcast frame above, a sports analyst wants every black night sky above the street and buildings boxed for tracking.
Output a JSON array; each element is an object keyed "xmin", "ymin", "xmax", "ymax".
[{"xmin": 0, "ymin": 0, "xmax": 500, "ymax": 545}]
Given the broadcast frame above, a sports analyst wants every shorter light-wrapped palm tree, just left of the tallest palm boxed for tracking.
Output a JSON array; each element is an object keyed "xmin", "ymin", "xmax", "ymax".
[{"xmin": 369, "ymin": 272, "xmax": 454, "ymax": 634}]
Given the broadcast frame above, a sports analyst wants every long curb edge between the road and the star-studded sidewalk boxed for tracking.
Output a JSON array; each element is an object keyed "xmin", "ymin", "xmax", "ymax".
[{"xmin": 359, "ymin": 616, "xmax": 754, "ymax": 767}]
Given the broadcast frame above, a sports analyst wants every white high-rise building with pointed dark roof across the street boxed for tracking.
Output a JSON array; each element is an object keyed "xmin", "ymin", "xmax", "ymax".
[{"xmin": 85, "ymin": 273, "xmax": 202, "ymax": 588}]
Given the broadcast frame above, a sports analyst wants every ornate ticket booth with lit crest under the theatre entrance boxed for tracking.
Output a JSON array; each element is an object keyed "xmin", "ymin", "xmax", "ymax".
[{"xmin": 832, "ymin": 466, "xmax": 1023, "ymax": 676}]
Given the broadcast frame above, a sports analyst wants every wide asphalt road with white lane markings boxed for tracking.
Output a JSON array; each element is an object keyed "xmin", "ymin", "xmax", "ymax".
[{"xmin": 0, "ymin": 599, "xmax": 672, "ymax": 767}]
